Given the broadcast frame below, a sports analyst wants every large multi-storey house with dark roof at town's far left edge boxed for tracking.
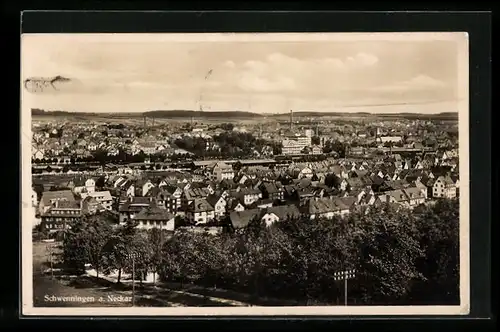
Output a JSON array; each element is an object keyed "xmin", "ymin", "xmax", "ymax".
[{"xmin": 40, "ymin": 198, "xmax": 82, "ymax": 232}]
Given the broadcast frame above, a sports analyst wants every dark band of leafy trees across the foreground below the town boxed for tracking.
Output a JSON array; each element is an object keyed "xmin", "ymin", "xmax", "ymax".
[{"xmin": 56, "ymin": 200, "xmax": 459, "ymax": 305}]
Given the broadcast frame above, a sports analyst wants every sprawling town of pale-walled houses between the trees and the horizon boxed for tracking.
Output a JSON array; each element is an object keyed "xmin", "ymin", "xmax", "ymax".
[{"xmin": 32, "ymin": 112, "xmax": 459, "ymax": 232}]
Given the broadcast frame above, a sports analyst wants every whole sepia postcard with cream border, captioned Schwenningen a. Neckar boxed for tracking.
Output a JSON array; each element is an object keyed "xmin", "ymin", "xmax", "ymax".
[{"xmin": 20, "ymin": 32, "xmax": 470, "ymax": 316}]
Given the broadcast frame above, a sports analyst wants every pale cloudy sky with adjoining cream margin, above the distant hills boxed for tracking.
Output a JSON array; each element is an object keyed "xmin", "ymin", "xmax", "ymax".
[{"xmin": 21, "ymin": 34, "xmax": 467, "ymax": 113}]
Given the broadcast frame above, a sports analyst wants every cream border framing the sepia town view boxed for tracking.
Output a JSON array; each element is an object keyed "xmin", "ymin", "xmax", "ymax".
[{"xmin": 21, "ymin": 32, "xmax": 470, "ymax": 317}]
